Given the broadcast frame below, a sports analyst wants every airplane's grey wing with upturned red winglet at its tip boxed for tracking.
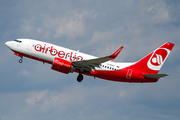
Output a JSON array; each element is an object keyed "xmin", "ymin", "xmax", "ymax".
[{"xmin": 72, "ymin": 46, "xmax": 123, "ymax": 72}]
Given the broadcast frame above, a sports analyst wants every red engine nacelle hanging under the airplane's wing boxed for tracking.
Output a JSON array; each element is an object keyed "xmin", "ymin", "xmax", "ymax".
[{"xmin": 51, "ymin": 58, "xmax": 73, "ymax": 74}]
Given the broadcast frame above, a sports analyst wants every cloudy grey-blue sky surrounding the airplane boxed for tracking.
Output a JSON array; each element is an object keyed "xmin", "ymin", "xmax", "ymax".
[{"xmin": 0, "ymin": 0, "xmax": 180, "ymax": 120}]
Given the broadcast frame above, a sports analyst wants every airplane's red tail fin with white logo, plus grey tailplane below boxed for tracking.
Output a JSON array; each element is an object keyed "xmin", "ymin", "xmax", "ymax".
[{"xmin": 131, "ymin": 42, "xmax": 174, "ymax": 74}]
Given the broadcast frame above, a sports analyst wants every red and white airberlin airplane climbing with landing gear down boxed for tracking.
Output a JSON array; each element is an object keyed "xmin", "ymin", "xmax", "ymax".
[{"xmin": 5, "ymin": 39, "xmax": 174, "ymax": 83}]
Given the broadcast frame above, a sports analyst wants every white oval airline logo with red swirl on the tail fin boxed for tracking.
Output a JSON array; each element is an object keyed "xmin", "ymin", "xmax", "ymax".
[{"xmin": 147, "ymin": 48, "xmax": 170, "ymax": 70}]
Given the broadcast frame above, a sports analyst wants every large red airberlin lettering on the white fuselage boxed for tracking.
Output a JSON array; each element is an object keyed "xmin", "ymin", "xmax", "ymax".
[{"xmin": 33, "ymin": 44, "xmax": 83, "ymax": 61}]
